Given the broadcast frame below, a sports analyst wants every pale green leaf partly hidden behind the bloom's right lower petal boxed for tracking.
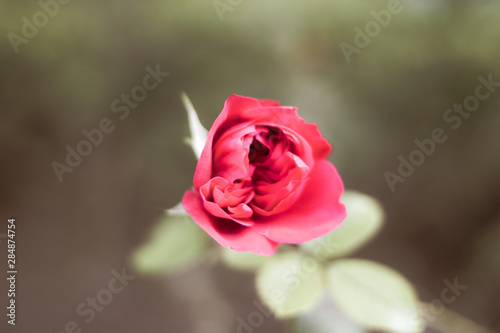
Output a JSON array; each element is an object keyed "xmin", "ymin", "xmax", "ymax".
[{"xmin": 300, "ymin": 191, "xmax": 384, "ymax": 260}]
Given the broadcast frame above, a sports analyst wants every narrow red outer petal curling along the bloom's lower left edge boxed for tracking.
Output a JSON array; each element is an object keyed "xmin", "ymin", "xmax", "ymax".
[{"xmin": 182, "ymin": 190, "xmax": 278, "ymax": 256}]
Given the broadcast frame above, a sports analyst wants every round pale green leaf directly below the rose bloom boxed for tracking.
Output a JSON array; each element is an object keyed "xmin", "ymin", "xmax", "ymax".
[{"xmin": 256, "ymin": 252, "xmax": 323, "ymax": 318}]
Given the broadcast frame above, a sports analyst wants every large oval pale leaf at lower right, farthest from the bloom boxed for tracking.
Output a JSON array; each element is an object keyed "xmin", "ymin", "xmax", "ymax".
[{"xmin": 327, "ymin": 259, "xmax": 424, "ymax": 333}]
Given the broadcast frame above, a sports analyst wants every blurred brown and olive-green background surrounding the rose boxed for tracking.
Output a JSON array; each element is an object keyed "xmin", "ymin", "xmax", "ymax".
[{"xmin": 0, "ymin": 0, "xmax": 500, "ymax": 333}]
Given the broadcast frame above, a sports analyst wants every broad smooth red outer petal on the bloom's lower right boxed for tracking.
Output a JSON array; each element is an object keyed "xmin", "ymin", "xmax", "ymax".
[{"xmin": 252, "ymin": 160, "xmax": 346, "ymax": 244}]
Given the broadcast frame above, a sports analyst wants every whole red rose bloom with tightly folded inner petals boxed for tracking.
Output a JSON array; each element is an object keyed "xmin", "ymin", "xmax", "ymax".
[{"xmin": 182, "ymin": 95, "xmax": 346, "ymax": 256}]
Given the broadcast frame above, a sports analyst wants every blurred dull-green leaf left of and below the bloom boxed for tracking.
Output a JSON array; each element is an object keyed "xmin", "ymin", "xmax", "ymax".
[{"xmin": 132, "ymin": 206, "xmax": 209, "ymax": 275}]
